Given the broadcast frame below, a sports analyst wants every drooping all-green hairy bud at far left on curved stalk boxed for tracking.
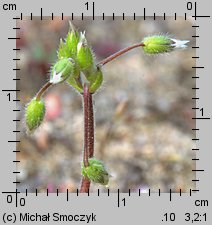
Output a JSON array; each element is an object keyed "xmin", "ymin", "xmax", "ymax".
[{"xmin": 25, "ymin": 98, "xmax": 45, "ymax": 131}]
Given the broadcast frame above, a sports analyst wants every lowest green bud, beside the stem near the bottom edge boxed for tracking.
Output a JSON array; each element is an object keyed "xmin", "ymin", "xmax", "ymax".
[{"xmin": 82, "ymin": 158, "xmax": 109, "ymax": 185}]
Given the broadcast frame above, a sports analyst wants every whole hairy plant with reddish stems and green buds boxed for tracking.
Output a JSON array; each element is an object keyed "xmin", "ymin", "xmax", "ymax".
[{"xmin": 25, "ymin": 23, "xmax": 189, "ymax": 192}]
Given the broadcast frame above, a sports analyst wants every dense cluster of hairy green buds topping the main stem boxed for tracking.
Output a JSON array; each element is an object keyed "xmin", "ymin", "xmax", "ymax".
[{"xmin": 50, "ymin": 24, "xmax": 103, "ymax": 93}]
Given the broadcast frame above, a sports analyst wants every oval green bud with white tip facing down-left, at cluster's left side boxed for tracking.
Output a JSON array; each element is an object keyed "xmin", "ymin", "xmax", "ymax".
[{"xmin": 50, "ymin": 58, "xmax": 75, "ymax": 84}]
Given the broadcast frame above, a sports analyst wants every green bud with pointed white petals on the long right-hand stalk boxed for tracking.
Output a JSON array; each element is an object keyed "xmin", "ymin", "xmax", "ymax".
[{"xmin": 142, "ymin": 35, "xmax": 189, "ymax": 54}]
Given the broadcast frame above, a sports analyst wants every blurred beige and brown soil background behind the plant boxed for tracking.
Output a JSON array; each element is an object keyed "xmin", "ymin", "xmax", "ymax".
[{"xmin": 17, "ymin": 17, "xmax": 195, "ymax": 192}]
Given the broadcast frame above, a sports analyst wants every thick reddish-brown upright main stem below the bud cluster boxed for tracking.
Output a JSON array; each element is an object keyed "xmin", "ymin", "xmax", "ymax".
[{"xmin": 80, "ymin": 84, "xmax": 94, "ymax": 193}]
